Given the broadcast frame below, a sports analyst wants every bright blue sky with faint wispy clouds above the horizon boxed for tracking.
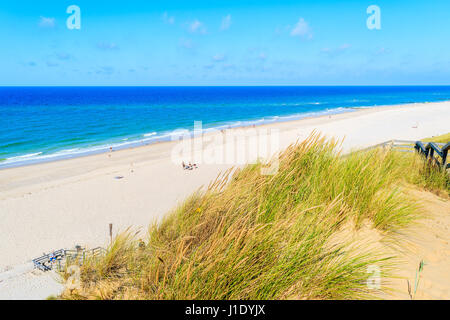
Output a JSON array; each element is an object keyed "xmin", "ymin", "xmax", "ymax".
[{"xmin": 0, "ymin": 0, "xmax": 450, "ymax": 85}]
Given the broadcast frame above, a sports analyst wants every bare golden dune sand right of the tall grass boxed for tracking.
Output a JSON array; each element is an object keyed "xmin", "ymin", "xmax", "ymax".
[{"xmin": 330, "ymin": 187, "xmax": 450, "ymax": 300}]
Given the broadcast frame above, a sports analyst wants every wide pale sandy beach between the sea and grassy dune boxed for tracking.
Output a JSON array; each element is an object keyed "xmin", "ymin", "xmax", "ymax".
[{"xmin": 0, "ymin": 102, "xmax": 450, "ymax": 298}]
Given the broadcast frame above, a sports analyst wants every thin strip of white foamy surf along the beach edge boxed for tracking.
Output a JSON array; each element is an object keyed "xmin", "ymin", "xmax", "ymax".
[{"xmin": 0, "ymin": 100, "xmax": 450, "ymax": 171}]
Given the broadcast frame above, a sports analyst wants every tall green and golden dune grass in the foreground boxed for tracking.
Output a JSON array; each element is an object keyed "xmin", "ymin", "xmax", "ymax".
[{"xmin": 60, "ymin": 135, "xmax": 448, "ymax": 299}]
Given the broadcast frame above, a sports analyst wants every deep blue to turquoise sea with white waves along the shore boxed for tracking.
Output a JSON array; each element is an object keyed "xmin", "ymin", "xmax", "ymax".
[{"xmin": 0, "ymin": 86, "xmax": 450, "ymax": 168}]
